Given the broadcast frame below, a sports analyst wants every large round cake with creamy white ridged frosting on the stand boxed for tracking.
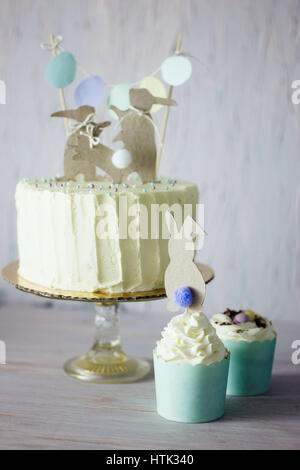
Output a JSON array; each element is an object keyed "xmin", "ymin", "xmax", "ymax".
[{"xmin": 16, "ymin": 178, "xmax": 198, "ymax": 293}]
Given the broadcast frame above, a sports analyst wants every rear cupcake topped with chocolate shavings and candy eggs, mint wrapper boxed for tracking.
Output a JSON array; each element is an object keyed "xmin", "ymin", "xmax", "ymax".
[{"xmin": 211, "ymin": 309, "xmax": 277, "ymax": 396}]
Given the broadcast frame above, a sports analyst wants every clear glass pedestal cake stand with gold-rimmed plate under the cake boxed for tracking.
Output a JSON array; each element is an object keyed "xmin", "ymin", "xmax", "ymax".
[{"xmin": 2, "ymin": 261, "xmax": 214, "ymax": 383}]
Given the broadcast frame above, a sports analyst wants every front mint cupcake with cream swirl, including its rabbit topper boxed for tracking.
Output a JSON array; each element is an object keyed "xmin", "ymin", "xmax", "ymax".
[{"xmin": 153, "ymin": 212, "xmax": 229, "ymax": 423}]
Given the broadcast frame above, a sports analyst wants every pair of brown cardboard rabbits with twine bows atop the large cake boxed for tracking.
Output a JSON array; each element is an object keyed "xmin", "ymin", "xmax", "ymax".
[{"xmin": 51, "ymin": 88, "xmax": 177, "ymax": 183}]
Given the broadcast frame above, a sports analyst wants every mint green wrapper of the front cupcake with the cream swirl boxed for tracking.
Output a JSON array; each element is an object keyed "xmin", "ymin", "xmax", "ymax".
[{"xmin": 154, "ymin": 354, "xmax": 230, "ymax": 423}]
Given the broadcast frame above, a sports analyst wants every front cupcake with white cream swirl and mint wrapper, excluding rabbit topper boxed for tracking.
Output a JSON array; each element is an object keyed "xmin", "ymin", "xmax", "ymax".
[{"xmin": 153, "ymin": 309, "xmax": 229, "ymax": 423}]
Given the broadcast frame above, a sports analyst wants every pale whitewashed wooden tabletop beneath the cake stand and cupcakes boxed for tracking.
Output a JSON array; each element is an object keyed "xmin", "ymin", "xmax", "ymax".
[{"xmin": 0, "ymin": 301, "xmax": 300, "ymax": 450}]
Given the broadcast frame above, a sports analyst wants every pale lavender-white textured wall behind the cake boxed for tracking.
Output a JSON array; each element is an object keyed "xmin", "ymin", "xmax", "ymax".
[{"xmin": 0, "ymin": 0, "xmax": 300, "ymax": 319}]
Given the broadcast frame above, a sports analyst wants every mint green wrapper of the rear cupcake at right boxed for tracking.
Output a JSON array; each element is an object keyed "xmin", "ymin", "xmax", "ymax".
[{"xmin": 223, "ymin": 337, "xmax": 276, "ymax": 396}]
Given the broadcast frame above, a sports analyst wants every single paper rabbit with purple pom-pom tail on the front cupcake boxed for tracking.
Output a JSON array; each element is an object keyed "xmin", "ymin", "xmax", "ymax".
[{"xmin": 165, "ymin": 212, "xmax": 205, "ymax": 312}]
